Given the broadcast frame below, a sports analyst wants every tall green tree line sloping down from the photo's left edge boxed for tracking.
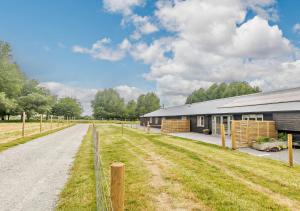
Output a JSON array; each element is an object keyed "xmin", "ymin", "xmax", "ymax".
[{"xmin": 0, "ymin": 41, "xmax": 82, "ymax": 120}]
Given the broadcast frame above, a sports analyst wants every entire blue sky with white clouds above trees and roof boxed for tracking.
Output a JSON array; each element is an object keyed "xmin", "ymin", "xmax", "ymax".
[{"xmin": 0, "ymin": 0, "xmax": 300, "ymax": 115}]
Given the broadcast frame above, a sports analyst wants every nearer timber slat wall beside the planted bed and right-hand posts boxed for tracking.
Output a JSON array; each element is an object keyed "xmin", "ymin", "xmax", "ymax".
[{"xmin": 232, "ymin": 120, "xmax": 278, "ymax": 147}]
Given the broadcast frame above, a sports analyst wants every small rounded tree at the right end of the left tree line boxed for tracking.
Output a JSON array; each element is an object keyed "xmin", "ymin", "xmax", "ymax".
[{"xmin": 51, "ymin": 97, "xmax": 82, "ymax": 118}]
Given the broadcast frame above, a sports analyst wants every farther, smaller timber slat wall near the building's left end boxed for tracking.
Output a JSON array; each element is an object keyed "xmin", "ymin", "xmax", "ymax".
[{"xmin": 161, "ymin": 120, "xmax": 191, "ymax": 133}]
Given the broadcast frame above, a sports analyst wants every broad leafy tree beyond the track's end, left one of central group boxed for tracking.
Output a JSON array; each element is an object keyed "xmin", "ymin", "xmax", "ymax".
[{"xmin": 92, "ymin": 89, "xmax": 125, "ymax": 119}]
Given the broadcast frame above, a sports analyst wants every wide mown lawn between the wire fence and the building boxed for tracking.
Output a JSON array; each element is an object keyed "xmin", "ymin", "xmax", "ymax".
[{"xmin": 98, "ymin": 126, "xmax": 300, "ymax": 210}]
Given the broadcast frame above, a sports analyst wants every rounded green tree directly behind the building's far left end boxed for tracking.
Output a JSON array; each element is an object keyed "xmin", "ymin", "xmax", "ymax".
[{"xmin": 136, "ymin": 92, "xmax": 160, "ymax": 116}]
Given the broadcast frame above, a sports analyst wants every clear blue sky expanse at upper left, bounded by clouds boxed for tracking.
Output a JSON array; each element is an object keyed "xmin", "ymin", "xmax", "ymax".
[{"xmin": 0, "ymin": 0, "xmax": 153, "ymax": 89}]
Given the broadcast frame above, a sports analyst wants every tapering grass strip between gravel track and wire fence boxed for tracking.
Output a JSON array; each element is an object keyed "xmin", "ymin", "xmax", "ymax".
[{"xmin": 56, "ymin": 128, "xmax": 96, "ymax": 210}]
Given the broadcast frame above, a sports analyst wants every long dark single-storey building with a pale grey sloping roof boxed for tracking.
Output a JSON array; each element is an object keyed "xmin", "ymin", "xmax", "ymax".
[{"xmin": 140, "ymin": 87, "xmax": 300, "ymax": 138}]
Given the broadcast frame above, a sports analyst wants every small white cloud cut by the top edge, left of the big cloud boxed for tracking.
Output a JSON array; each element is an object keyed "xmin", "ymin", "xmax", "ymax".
[{"xmin": 103, "ymin": 0, "xmax": 144, "ymax": 15}]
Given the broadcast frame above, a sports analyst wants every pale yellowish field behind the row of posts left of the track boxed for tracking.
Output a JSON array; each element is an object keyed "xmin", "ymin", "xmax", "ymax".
[{"xmin": 0, "ymin": 122, "xmax": 67, "ymax": 143}]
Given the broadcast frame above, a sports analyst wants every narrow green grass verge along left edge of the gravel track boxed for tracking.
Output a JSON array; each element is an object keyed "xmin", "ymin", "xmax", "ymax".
[{"xmin": 0, "ymin": 125, "xmax": 73, "ymax": 152}]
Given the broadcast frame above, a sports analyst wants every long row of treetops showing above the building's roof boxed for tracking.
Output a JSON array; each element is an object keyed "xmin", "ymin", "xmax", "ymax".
[{"xmin": 186, "ymin": 82, "xmax": 260, "ymax": 104}]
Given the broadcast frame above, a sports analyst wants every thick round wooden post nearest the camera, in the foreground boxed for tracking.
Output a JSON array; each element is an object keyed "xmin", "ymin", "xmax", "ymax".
[{"xmin": 110, "ymin": 163, "xmax": 125, "ymax": 211}]
